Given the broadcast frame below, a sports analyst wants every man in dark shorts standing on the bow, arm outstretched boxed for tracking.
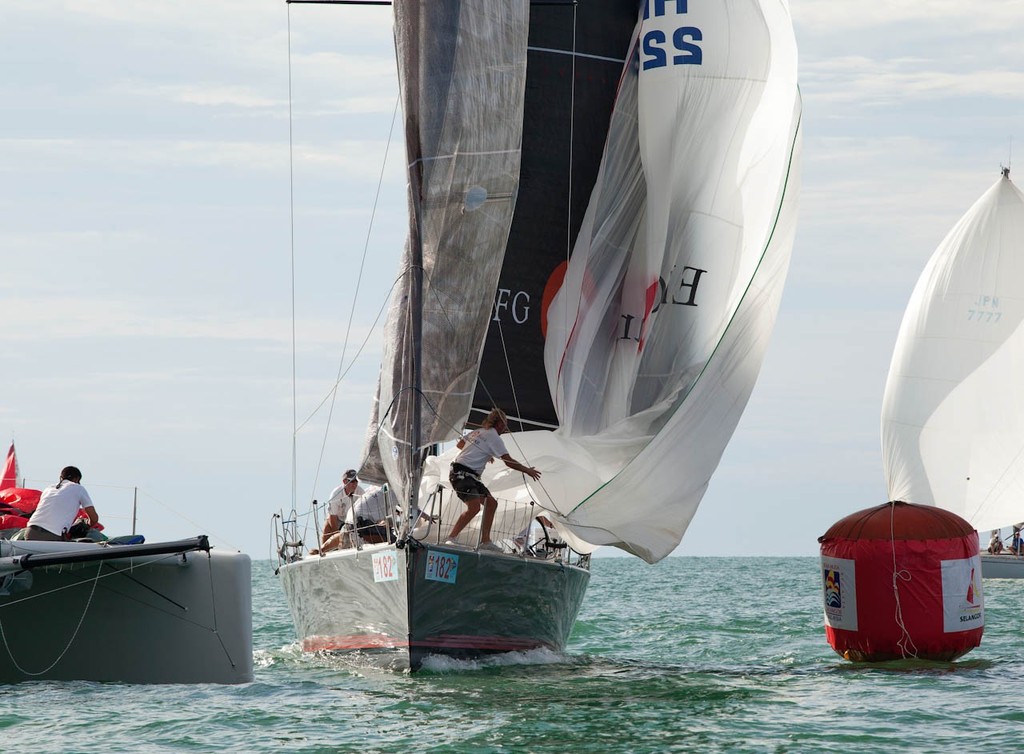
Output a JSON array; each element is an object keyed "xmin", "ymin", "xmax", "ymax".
[{"xmin": 444, "ymin": 409, "xmax": 541, "ymax": 552}]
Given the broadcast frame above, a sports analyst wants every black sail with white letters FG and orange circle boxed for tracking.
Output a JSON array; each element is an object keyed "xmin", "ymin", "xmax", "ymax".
[{"xmin": 470, "ymin": 0, "xmax": 638, "ymax": 429}]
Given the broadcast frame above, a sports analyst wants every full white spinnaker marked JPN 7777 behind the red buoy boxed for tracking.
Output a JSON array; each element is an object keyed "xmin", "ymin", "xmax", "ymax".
[{"xmin": 882, "ymin": 171, "xmax": 1024, "ymax": 530}]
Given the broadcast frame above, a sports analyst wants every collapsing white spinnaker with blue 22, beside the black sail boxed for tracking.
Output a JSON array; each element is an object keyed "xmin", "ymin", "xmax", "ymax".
[{"xmin": 532, "ymin": 0, "xmax": 801, "ymax": 561}]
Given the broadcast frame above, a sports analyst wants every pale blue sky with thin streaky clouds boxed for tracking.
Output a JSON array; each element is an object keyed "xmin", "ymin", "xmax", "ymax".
[{"xmin": 0, "ymin": 0, "xmax": 1024, "ymax": 559}]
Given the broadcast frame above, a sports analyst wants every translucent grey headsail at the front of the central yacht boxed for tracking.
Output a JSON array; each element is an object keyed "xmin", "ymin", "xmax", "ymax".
[{"xmin": 362, "ymin": 0, "xmax": 528, "ymax": 499}]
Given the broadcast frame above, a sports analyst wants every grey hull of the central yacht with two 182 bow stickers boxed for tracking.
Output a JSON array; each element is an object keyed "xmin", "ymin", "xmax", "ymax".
[{"xmin": 281, "ymin": 545, "xmax": 590, "ymax": 670}]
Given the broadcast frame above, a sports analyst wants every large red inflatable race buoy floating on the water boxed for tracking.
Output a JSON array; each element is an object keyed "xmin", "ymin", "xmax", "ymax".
[{"xmin": 818, "ymin": 501, "xmax": 985, "ymax": 662}]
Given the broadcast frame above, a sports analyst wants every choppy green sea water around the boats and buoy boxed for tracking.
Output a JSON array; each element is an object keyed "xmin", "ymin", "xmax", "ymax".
[{"xmin": 0, "ymin": 557, "xmax": 1024, "ymax": 754}]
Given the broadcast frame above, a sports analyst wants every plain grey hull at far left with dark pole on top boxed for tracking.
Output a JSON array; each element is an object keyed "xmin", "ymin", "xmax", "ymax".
[{"xmin": 0, "ymin": 542, "xmax": 253, "ymax": 683}]
